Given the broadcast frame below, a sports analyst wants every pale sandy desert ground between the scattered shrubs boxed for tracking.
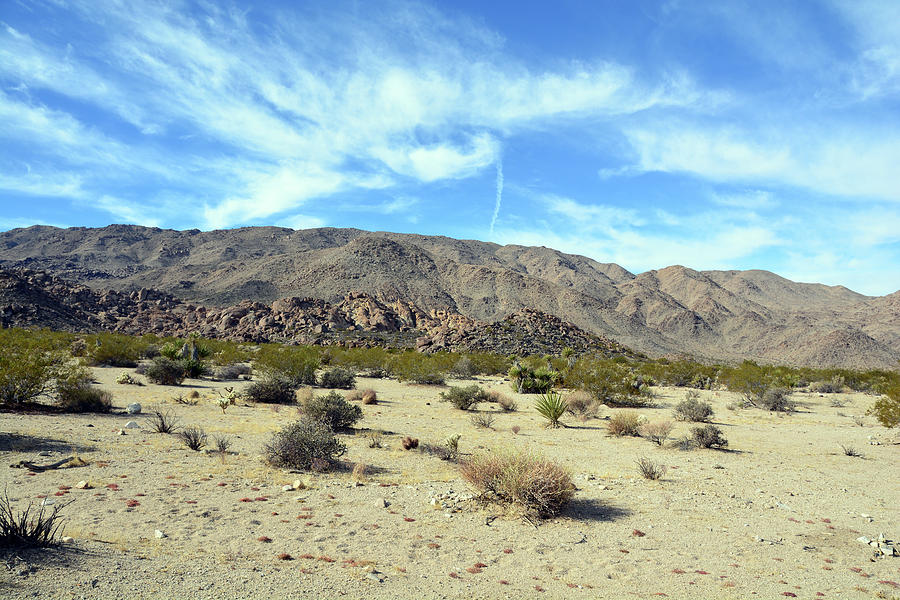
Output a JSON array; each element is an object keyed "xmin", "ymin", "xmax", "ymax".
[{"xmin": 0, "ymin": 369, "xmax": 900, "ymax": 599}]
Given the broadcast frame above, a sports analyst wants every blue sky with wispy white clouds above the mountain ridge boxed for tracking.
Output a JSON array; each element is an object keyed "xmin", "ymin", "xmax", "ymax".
[{"xmin": 0, "ymin": 0, "xmax": 900, "ymax": 295}]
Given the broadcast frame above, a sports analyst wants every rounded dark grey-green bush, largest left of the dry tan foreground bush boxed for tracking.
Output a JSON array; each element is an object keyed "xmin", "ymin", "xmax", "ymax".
[{"xmin": 263, "ymin": 417, "xmax": 347, "ymax": 470}]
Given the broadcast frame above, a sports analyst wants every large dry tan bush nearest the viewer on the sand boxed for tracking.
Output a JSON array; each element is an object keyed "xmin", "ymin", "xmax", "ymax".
[{"xmin": 460, "ymin": 452, "xmax": 575, "ymax": 517}]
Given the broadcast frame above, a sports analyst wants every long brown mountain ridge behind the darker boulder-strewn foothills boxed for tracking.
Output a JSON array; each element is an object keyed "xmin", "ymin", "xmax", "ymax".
[{"xmin": 0, "ymin": 225, "xmax": 900, "ymax": 368}]
